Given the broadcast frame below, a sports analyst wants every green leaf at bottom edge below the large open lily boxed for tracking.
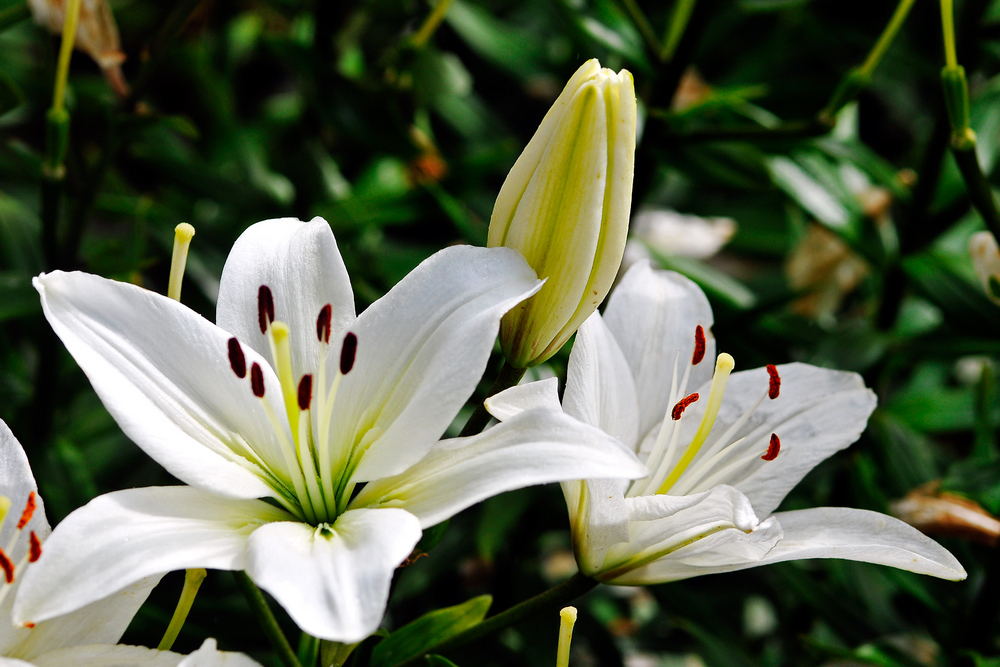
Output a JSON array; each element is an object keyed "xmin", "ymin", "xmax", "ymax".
[{"xmin": 371, "ymin": 595, "xmax": 493, "ymax": 667}]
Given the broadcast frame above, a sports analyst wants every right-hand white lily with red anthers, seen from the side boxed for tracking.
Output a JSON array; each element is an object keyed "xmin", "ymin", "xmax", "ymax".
[{"xmin": 487, "ymin": 262, "xmax": 965, "ymax": 584}]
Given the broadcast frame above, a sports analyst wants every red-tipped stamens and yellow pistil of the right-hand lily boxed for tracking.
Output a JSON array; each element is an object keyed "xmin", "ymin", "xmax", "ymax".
[{"xmin": 626, "ymin": 325, "xmax": 781, "ymax": 497}]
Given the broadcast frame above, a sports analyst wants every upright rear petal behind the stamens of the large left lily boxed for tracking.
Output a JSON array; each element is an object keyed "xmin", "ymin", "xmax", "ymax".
[{"xmin": 216, "ymin": 218, "xmax": 354, "ymax": 380}]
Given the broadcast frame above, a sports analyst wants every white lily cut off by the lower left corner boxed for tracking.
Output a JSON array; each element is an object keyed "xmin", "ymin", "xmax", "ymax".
[{"xmin": 0, "ymin": 420, "xmax": 260, "ymax": 667}]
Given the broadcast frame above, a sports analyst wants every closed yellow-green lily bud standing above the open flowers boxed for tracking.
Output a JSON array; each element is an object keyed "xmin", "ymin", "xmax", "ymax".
[{"xmin": 488, "ymin": 60, "xmax": 636, "ymax": 368}]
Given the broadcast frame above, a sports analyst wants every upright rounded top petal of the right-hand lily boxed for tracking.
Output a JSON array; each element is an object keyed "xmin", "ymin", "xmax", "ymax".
[{"xmin": 604, "ymin": 262, "xmax": 715, "ymax": 437}]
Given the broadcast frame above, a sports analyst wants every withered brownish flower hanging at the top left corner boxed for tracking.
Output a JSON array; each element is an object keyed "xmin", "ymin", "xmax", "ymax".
[{"xmin": 28, "ymin": 0, "xmax": 129, "ymax": 97}]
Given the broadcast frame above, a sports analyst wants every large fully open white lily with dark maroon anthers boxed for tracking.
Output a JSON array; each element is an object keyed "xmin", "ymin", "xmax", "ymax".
[{"xmin": 15, "ymin": 218, "xmax": 644, "ymax": 643}]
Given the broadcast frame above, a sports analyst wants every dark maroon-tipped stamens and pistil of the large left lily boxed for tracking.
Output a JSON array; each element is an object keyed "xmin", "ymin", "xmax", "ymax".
[{"xmin": 227, "ymin": 285, "xmax": 358, "ymax": 525}]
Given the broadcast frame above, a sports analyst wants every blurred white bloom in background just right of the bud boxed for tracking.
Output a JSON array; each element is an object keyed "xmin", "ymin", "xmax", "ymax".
[{"xmin": 622, "ymin": 208, "xmax": 736, "ymax": 274}]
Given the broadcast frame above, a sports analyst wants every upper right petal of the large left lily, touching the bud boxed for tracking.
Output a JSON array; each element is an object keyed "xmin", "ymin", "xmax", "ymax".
[{"xmin": 327, "ymin": 246, "xmax": 541, "ymax": 482}]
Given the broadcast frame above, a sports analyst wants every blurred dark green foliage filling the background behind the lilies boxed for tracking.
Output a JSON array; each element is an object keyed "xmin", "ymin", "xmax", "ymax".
[{"xmin": 0, "ymin": 0, "xmax": 1000, "ymax": 667}]
